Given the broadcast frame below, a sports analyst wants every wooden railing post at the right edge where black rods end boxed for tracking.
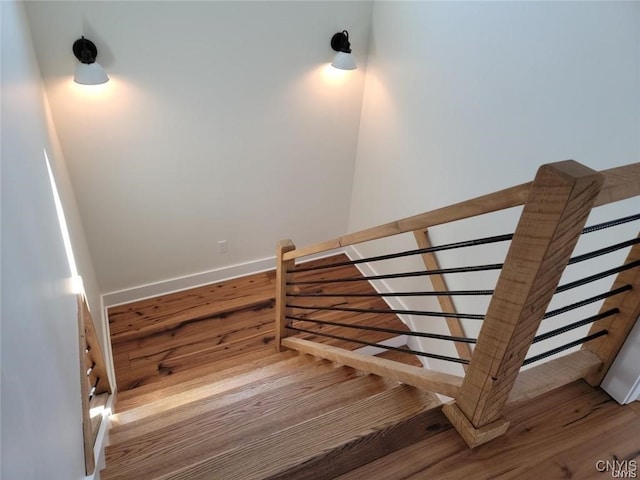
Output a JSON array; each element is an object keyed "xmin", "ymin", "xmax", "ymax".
[{"xmin": 582, "ymin": 234, "xmax": 640, "ymax": 386}]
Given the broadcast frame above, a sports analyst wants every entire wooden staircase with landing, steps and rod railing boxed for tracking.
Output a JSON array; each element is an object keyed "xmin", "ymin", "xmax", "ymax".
[{"xmin": 102, "ymin": 161, "xmax": 640, "ymax": 480}]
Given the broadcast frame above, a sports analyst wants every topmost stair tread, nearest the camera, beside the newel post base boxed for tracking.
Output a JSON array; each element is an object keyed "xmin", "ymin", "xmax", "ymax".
[{"xmin": 151, "ymin": 385, "xmax": 439, "ymax": 480}]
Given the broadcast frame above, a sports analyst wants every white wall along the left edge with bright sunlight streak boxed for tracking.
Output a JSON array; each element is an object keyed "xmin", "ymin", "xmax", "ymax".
[{"xmin": 0, "ymin": 1, "xmax": 100, "ymax": 480}]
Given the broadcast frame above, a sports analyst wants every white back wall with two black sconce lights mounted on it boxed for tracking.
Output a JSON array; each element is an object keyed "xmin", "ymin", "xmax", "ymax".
[{"xmin": 27, "ymin": 1, "xmax": 372, "ymax": 293}]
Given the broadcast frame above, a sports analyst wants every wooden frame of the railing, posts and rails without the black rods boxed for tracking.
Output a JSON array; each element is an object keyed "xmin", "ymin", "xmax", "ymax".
[{"xmin": 276, "ymin": 160, "xmax": 640, "ymax": 447}]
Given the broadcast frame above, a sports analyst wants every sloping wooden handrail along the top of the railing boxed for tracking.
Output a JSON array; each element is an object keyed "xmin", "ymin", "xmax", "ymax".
[{"xmin": 283, "ymin": 163, "xmax": 640, "ymax": 260}]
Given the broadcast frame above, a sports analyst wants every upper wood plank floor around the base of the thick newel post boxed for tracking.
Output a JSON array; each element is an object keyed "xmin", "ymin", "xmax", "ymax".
[{"xmin": 337, "ymin": 381, "xmax": 640, "ymax": 480}]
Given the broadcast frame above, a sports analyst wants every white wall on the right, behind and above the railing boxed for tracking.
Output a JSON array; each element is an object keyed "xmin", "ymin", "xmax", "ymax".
[{"xmin": 349, "ymin": 2, "xmax": 640, "ymax": 376}]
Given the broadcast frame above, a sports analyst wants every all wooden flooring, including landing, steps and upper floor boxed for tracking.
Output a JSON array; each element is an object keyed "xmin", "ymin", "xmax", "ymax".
[{"xmin": 102, "ymin": 253, "xmax": 640, "ymax": 480}]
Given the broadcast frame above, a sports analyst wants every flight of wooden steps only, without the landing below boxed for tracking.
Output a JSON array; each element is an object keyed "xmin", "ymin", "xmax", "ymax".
[{"xmin": 101, "ymin": 352, "xmax": 439, "ymax": 480}]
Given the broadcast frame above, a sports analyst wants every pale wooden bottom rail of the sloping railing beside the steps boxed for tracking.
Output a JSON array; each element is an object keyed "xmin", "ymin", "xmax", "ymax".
[{"xmin": 283, "ymin": 337, "xmax": 462, "ymax": 397}]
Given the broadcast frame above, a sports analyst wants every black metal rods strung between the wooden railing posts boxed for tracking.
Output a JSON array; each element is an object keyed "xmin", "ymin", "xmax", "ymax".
[{"xmin": 286, "ymin": 214, "xmax": 640, "ymax": 365}]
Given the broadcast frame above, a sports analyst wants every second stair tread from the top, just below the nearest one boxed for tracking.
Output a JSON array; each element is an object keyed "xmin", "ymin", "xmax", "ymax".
[{"xmin": 104, "ymin": 367, "xmax": 400, "ymax": 479}]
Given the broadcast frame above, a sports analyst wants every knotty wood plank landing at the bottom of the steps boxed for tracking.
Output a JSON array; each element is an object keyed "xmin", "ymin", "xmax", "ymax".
[{"xmin": 108, "ymin": 255, "xmax": 416, "ymax": 400}]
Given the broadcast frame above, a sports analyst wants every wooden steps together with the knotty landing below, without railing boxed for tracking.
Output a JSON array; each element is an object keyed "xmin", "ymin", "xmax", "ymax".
[{"xmin": 101, "ymin": 258, "xmax": 442, "ymax": 480}]
